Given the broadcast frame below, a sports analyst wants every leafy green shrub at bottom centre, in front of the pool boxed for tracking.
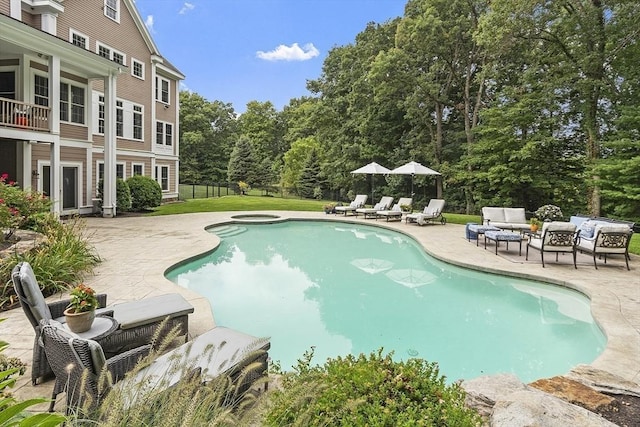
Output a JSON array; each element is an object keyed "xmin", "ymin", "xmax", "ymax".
[{"xmin": 263, "ymin": 350, "xmax": 481, "ymax": 427}]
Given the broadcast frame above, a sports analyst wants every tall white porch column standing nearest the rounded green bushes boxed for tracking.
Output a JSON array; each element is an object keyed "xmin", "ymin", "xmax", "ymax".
[{"xmin": 102, "ymin": 75, "xmax": 116, "ymax": 218}]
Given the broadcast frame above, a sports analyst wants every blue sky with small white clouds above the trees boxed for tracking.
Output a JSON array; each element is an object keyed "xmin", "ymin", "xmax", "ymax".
[{"xmin": 135, "ymin": 0, "xmax": 406, "ymax": 113}]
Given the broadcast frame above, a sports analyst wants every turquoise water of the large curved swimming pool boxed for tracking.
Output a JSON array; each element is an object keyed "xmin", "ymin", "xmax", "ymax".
[{"xmin": 167, "ymin": 221, "xmax": 606, "ymax": 382}]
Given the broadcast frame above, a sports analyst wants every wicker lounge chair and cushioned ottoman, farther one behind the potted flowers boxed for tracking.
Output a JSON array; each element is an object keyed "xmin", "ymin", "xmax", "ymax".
[{"xmin": 11, "ymin": 262, "xmax": 193, "ymax": 385}]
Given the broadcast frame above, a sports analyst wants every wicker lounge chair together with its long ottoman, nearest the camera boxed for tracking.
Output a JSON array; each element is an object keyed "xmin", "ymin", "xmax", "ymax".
[{"xmin": 41, "ymin": 320, "xmax": 270, "ymax": 413}]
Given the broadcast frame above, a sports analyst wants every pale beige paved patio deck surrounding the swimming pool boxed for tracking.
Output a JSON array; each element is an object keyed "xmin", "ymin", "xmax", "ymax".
[{"xmin": 5, "ymin": 211, "xmax": 640, "ymax": 410}]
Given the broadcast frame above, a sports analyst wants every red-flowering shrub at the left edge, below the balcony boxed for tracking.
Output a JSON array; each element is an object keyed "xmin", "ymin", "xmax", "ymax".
[{"xmin": 0, "ymin": 173, "xmax": 50, "ymax": 241}]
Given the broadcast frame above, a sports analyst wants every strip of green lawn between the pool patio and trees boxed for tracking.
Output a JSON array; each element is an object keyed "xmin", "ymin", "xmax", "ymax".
[{"xmin": 148, "ymin": 196, "xmax": 640, "ymax": 255}]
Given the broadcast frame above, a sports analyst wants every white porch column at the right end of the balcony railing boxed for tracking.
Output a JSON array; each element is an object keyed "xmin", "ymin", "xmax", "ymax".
[{"xmin": 49, "ymin": 56, "xmax": 62, "ymax": 216}]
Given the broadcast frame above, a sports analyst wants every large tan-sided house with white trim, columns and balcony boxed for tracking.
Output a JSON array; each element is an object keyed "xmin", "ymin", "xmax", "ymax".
[{"xmin": 0, "ymin": 0, "xmax": 184, "ymax": 217}]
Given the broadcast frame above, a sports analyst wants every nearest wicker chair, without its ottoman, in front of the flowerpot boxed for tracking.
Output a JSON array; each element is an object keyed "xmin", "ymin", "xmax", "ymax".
[{"xmin": 40, "ymin": 320, "xmax": 151, "ymax": 413}]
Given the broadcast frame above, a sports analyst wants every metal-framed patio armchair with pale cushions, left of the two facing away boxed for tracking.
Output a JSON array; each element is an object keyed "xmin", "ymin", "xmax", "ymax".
[{"xmin": 525, "ymin": 221, "xmax": 578, "ymax": 268}]
